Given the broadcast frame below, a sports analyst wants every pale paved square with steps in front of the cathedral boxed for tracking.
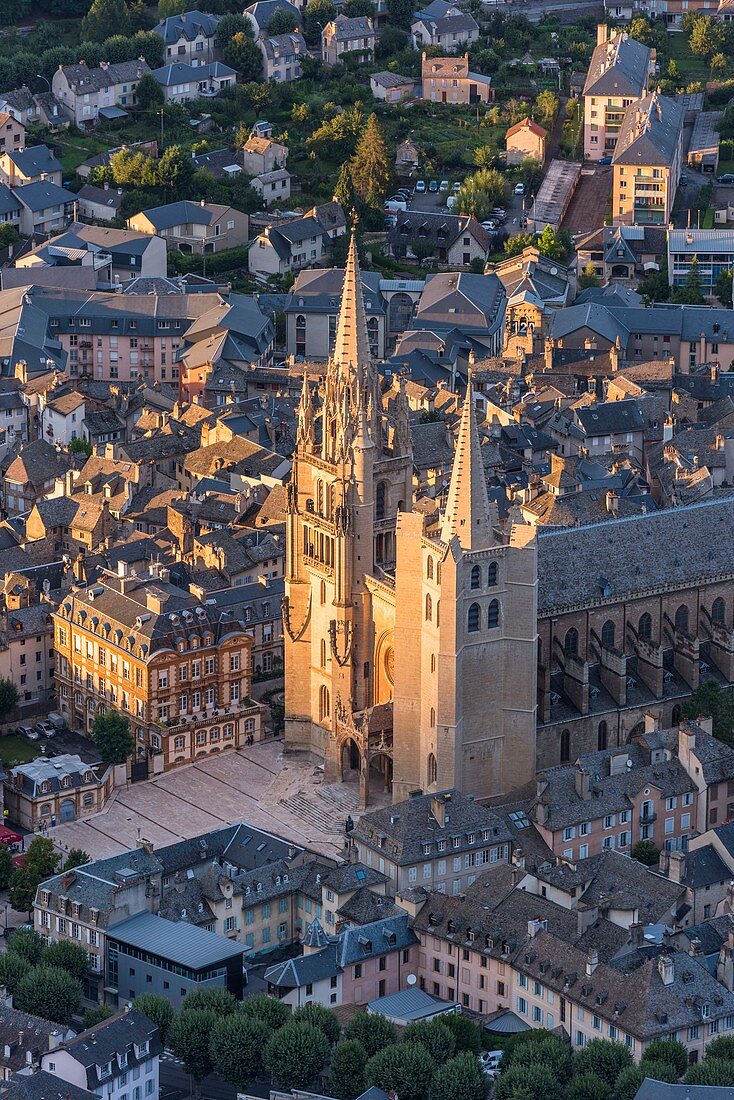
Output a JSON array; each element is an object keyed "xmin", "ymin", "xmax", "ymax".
[{"xmin": 48, "ymin": 741, "xmax": 367, "ymax": 859}]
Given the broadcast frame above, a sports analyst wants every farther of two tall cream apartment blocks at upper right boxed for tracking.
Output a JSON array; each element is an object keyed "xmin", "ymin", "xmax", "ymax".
[{"xmin": 583, "ymin": 24, "xmax": 655, "ymax": 161}]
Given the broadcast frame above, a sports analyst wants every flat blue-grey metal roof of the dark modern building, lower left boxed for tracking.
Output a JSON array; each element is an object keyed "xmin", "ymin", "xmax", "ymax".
[{"xmin": 107, "ymin": 913, "xmax": 245, "ymax": 970}]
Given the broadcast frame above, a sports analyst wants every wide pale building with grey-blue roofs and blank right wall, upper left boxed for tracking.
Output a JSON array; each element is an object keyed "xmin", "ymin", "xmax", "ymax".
[{"xmin": 15, "ymin": 224, "xmax": 167, "ymax": 290}]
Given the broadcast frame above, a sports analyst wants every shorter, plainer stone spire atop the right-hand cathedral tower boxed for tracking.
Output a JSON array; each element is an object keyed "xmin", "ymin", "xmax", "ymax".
[{"xmin": 441, "ymin": 381, "xmax": 493, "ymax": 550}]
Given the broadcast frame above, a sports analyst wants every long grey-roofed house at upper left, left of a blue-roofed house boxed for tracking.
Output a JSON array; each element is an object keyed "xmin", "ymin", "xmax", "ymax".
[{"xmin": 52, "ymin": 61, "xmax": 151, "ymax": 129}]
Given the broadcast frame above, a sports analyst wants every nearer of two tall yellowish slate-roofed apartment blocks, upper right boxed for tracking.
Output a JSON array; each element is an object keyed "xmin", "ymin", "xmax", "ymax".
[{"xmin": 612, "ymin": 91, "xmax": 686, "ymax": 226}]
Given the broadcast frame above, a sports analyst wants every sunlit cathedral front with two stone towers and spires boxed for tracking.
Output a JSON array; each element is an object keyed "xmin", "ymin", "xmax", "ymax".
[{"xmin": 283, "ymin": 227, "xmax": 538, "ymax": 806}]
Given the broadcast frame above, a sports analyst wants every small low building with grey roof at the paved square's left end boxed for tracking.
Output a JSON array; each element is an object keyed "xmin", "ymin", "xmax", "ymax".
[{"xmin": 3, "ymin": 752, "xmax": 113, "ymax": 833}]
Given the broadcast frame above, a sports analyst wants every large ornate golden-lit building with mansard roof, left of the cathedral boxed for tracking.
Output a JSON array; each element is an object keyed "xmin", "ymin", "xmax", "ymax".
[{"xmin": 54, "ymin": 561, "xmax": 261, "ymax": 776}]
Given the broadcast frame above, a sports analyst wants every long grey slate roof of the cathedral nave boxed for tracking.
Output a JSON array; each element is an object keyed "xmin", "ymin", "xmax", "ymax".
[{"xmin": 538, "ymin": 498, "xmax": 734, "ymax": 616}]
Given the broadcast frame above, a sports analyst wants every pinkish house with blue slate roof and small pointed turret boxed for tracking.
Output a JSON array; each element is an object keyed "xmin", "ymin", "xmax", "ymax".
[{"xmin": 264, "ymin": 913, "xmax": 418, "ymax": 1009}]
